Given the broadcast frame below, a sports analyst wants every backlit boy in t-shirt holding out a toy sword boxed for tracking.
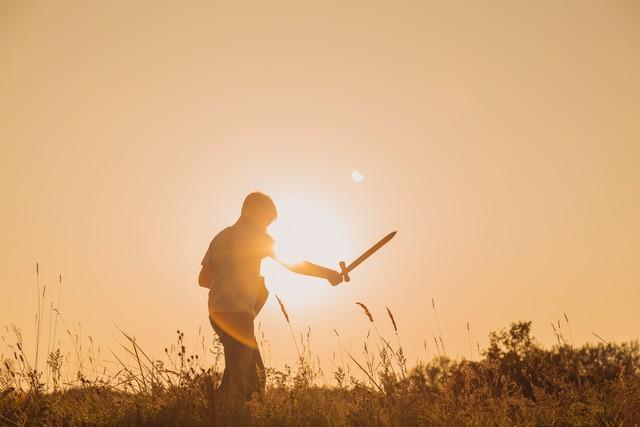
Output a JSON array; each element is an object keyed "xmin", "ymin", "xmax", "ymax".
[{"xmin": 198, "ymin": 192, "xmax": 342, "ymax": 400}]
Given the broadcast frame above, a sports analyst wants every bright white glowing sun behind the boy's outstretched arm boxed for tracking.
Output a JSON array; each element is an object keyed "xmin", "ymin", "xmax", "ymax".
[{"xmin": 262, "ymin": 197, "xmax": 352, "ymax": 306}]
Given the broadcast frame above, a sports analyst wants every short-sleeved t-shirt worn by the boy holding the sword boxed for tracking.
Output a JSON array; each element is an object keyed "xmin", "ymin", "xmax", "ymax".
[{"xmin": 202, "ymin": 222, "xmax": 273, "ymax": 316}]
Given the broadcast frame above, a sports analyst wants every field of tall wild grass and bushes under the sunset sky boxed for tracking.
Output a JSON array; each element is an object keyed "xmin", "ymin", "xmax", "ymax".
[{"xmin": 0, "ymin": 296, "xmax": 640, "ymax": 426}]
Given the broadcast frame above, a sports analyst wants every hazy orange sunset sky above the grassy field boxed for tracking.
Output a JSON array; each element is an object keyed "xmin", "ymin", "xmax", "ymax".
[{"xmin": 0, "ymin": 0, "xmax": 640, "ymax": 371}]
